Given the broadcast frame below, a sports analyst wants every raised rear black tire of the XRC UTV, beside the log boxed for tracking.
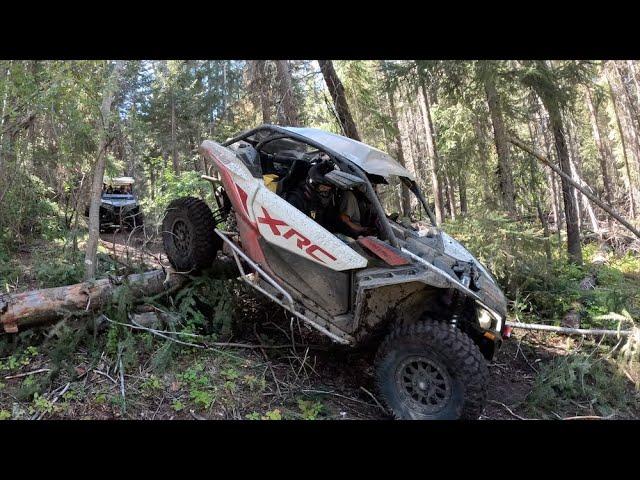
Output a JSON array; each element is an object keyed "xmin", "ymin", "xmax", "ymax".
[{"xmin": 162, "ymin": 197, "xmax": 222, "ymax": 272}]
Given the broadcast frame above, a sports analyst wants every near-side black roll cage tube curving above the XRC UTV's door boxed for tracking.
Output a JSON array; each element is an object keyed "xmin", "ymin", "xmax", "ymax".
[{"xmin": 222, "ymin": 125, "xmax": 398, "ymax": 248}]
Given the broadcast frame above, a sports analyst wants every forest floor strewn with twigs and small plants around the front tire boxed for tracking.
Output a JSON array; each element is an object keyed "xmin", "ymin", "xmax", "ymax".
[{"xmin": 0, "ymin": 229, "xmax": 640, "ymax": 420}]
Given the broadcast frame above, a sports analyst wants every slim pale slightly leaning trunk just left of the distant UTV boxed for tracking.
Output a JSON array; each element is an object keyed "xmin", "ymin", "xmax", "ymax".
[{"xmin": 84, "ymin": 60, "xmax": 125, "ymax": 280}]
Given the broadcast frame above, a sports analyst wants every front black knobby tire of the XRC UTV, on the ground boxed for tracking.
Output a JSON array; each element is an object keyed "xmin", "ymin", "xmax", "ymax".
[{"xmin": 375, "ymin": 320, "xmax": 489, "ymax": 420}]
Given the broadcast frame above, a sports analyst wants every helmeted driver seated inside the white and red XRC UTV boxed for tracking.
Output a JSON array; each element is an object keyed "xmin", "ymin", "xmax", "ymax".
[{"xmin": 284, "ymin": 156, "xmax": 335, "ymax": 229}]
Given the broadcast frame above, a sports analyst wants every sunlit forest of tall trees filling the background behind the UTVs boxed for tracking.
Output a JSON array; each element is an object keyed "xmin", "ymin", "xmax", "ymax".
[{"xmin": 0, "ymin": 60, "xmax": 640, "ymax": 262}]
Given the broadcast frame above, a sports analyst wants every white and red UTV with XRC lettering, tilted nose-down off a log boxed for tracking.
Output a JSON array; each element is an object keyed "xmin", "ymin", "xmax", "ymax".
[{"xmin": 163, "ymin": 125, "xmax": 506, "ymax": 419}]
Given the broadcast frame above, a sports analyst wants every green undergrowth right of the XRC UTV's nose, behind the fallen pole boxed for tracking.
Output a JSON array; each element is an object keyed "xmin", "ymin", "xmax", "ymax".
[{"xmin": 445, "ymin": 214, "xmax": 640, "ymax": 327}]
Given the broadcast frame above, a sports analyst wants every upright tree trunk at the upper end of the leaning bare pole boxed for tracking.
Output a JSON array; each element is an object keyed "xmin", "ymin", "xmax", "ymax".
[{"xmin": 481, "ymin": 61, "xmax": 516, "ymax": 214}]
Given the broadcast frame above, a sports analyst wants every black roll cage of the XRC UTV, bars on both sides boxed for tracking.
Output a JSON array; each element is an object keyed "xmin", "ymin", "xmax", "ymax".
[{"xmin": 222, "ymin": 124, "xmax": 437, "ymax": 248}]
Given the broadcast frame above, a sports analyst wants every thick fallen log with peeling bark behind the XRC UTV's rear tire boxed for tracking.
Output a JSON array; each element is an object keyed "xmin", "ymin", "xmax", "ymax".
[{"xmin": 0, "ymin": 270, "xmax": 187, "ymax": 333}]
